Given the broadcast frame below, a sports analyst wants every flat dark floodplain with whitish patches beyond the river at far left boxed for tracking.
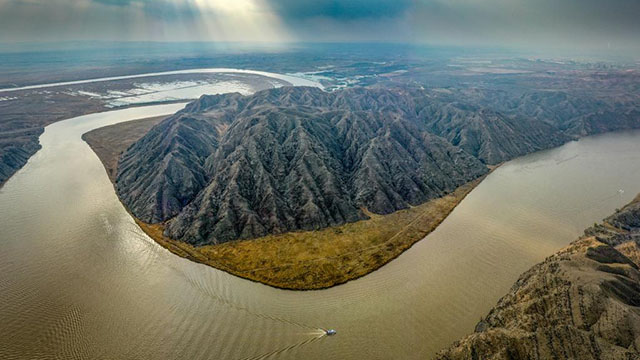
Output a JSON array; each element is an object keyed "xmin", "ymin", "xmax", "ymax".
[{"xmin": 0, "ymin": 68, "xmax": 312, "ymax": 188}]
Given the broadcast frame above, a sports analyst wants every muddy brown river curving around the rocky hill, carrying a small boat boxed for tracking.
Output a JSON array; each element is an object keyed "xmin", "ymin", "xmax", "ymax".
[{"xmin": 0, "ymin": 80, "xmax": 640, "ymax": 359}]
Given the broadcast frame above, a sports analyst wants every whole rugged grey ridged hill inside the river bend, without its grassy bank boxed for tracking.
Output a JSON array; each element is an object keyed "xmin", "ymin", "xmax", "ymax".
[{"xmin": 116, "ymin": 87, "xmax": 640, "ymax": 245}]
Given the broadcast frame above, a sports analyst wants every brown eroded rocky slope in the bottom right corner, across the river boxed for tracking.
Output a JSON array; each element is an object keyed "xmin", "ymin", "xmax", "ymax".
[{"xmin": 437, "ymin": 196, "xmax": 640, "ymax": 360}]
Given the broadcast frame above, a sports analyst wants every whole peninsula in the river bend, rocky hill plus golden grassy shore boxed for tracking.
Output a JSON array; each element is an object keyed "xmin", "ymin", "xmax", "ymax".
[{"xmin": 85, "ymin": 87, "xmax": 638, "ymax": 290}]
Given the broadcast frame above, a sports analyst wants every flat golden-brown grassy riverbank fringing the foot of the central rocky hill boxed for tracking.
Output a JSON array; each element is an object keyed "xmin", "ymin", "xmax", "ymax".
[{"xmin": 83, "ymin": 118, "xmax": 488, "ymax": 290}]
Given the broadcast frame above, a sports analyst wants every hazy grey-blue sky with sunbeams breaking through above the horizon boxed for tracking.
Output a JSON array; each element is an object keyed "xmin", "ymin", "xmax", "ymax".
[{"xmin": 0, "ymin": 0, "xmax": 640, "ymax": 52}]
